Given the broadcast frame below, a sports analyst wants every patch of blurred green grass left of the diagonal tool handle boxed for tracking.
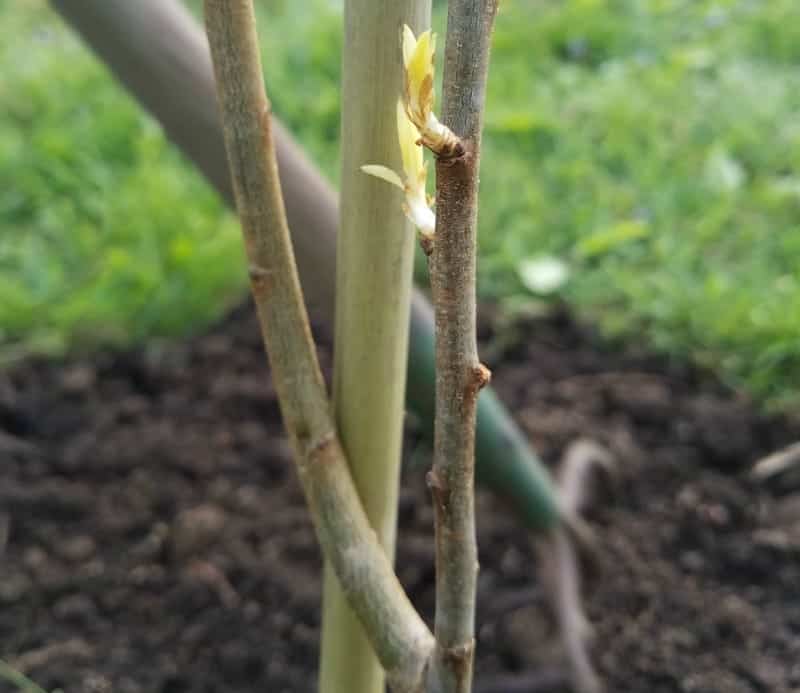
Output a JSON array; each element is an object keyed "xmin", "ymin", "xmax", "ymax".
[{"xmin": 0, "ymin": 2, "xmax": 244, "ymax": 360}]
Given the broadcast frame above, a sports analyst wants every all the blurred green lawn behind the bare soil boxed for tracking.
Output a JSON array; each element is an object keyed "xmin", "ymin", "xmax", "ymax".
[{"xmin": 0, "ymin": 0, "xmax": 800, "ymax": 406}]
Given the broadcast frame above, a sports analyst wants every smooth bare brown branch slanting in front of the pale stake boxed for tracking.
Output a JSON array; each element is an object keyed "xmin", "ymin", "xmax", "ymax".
[{"xmin": 205, "ymin": 0, "xmax": 433, "ymax": 693}]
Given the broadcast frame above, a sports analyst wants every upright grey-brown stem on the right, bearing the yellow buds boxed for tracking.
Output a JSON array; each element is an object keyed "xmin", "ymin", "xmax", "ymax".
[{"xmin": 429, "ymin": 0, "xmax": 497, "ymax": 693}]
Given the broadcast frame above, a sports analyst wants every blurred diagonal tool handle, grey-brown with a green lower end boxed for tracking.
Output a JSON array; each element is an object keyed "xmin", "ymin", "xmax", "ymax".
[{"xmin": 50, "ymin": 0, "xmax": 559, "ymax": 529}]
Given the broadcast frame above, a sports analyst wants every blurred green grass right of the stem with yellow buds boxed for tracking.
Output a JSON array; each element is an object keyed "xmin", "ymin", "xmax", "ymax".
[{"xmin": 481, "ymin": 0, "xmax": 800, "ymax": 404}]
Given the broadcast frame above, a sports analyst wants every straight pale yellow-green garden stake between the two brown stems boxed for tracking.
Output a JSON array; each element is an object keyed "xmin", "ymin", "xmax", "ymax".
[{"xmin": 320, "ymin": 0, "xmax": 430, "ymax": 693}]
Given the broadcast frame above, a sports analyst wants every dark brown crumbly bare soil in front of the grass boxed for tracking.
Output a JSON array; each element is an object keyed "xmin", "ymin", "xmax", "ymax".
[{"xmin": 0, "ymin": 306, "xmax": 800, "ymax": 693}]
